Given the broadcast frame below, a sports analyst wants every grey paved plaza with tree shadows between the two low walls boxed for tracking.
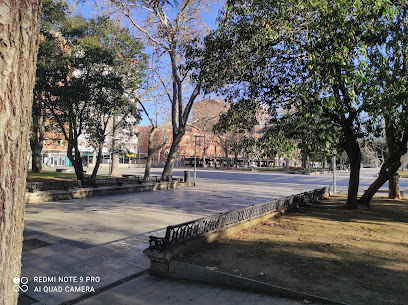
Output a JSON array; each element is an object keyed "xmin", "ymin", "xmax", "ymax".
[{"xmin": 20, "ymin": 168, "xmax": 407, "ymax": 305}]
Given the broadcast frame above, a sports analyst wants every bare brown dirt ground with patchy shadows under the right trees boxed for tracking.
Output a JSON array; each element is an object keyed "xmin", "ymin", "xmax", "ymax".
[{"xmin": 182, "ymin": 196, "xmax": 408, "ymax": 305}]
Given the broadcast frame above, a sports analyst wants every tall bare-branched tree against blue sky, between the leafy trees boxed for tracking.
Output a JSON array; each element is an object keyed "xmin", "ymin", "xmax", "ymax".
[{"xmin": 98, "ymin": 0, "xmax": 215, "ymax": 180}]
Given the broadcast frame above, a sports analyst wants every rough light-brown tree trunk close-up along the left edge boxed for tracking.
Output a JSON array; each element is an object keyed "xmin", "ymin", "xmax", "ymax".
[{"xmin": 0, "ymin": 0, "xmax": 41, "ymax": 305}]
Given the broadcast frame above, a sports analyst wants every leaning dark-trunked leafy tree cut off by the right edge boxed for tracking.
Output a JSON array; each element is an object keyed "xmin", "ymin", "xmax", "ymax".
[{"xmin": 360, "ymin": 1, "xmax": 408, "ymax": 207}]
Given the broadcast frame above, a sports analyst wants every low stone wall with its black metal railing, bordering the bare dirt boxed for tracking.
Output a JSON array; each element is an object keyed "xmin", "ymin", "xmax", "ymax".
[{"xmin": 144, "ymin": 187, "xmax": 330, "ymax": 278}]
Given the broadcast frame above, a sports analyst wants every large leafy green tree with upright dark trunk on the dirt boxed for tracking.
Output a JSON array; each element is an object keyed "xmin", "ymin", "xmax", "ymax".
[{"xmin": 203, "ymin": 0, "xmax": 384, "ymax": 208}]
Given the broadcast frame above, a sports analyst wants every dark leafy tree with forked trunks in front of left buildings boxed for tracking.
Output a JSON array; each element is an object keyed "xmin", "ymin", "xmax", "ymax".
[{"xmin": 47, "ymin": 16, "xmax": 144, "ymax": 180}]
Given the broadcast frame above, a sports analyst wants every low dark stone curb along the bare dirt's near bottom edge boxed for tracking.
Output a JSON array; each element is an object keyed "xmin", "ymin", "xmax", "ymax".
[{"xmin": 169, "ymin": 260, "xmax": 347, "ymax": 305}]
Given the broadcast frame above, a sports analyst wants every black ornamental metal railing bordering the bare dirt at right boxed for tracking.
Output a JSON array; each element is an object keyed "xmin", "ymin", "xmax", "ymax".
[{"xmin": 149, "ymin": 187, "xmax": 330, "ymax": 251}]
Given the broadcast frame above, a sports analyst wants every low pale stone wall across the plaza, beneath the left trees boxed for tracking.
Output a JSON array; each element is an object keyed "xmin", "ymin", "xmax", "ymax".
[{"xmin": 26, "ymin": 181, "xmax": 194, "ymax": 203}]
